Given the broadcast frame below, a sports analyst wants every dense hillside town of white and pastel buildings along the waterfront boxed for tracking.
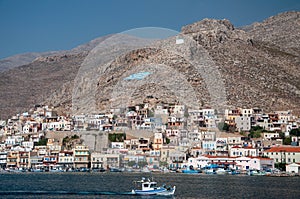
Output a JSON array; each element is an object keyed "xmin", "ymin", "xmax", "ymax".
[{"xmin": 0, "ymin": 103, "xmax": 300, "ymax": 174}]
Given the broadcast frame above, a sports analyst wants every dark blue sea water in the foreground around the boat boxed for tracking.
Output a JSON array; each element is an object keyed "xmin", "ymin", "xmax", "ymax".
[{"xmin": 0, "ymin": 173, "xmax": 300, "ymax": 199}]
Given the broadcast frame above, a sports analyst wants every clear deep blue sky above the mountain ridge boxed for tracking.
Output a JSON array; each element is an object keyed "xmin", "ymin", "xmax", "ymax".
[{"xmin": 0, "ymin": 0, "xmax": 300, "ymax": 58}]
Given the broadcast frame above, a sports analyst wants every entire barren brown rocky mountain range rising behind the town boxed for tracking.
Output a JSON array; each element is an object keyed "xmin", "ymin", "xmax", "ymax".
[{"xmin": 0, "ymin": 12, "xmax": 300, "ymax": 118}]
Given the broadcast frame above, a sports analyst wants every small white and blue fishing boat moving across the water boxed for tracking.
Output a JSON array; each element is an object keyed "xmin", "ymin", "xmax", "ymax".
[{"xmin": 132, "ymin": 178, "xmax": 176, "ymax": 196}]
